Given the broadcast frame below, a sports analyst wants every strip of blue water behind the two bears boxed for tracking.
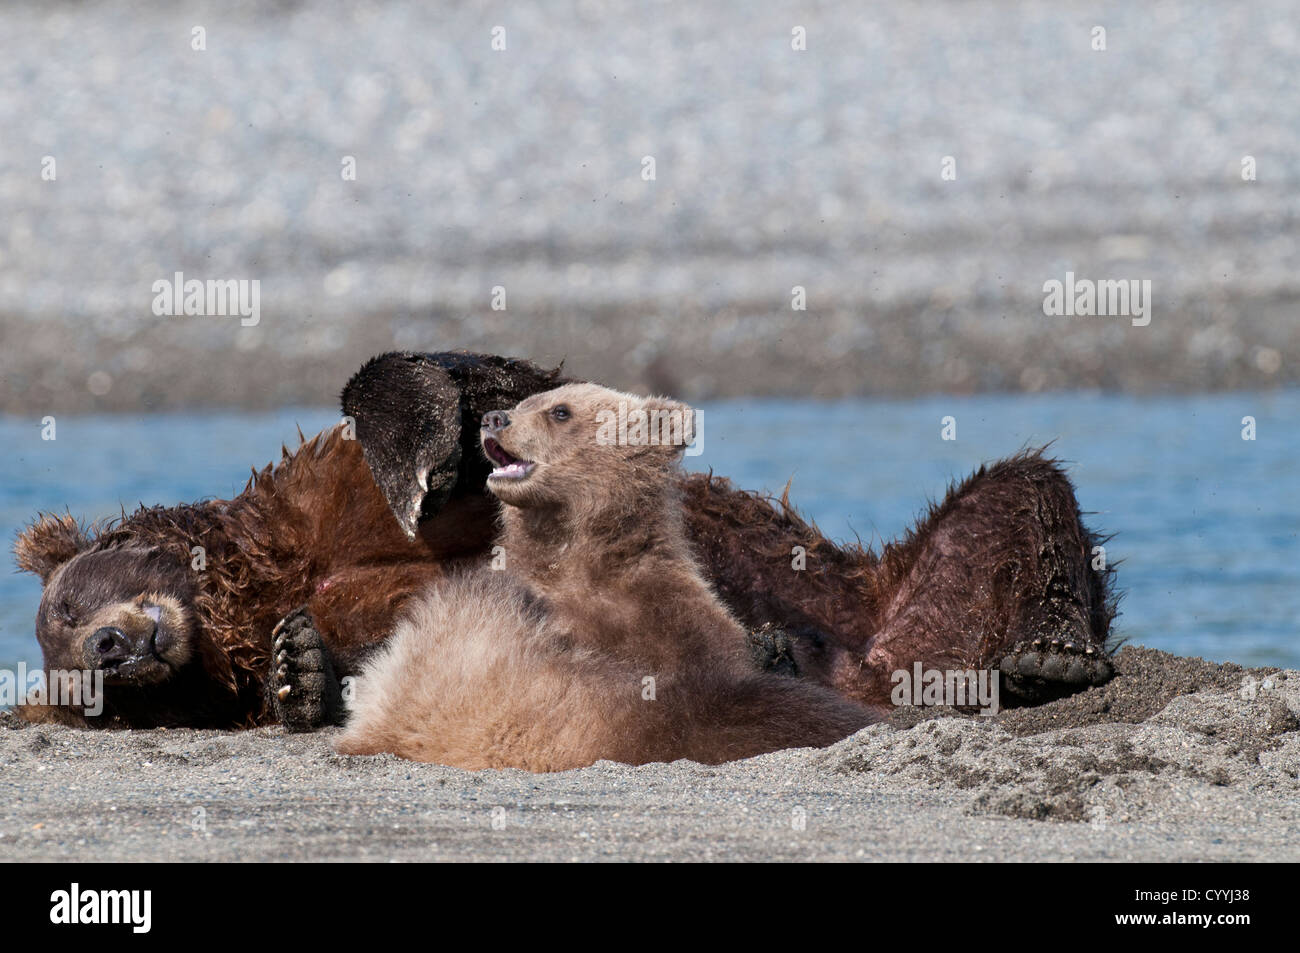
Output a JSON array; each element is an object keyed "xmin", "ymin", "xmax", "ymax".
[{"xmin": 0, "ymin": 391, "xmax": 1300, "ymax": 668}]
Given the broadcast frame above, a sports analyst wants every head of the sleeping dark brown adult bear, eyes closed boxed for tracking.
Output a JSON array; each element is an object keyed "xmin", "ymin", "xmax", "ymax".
[{"xmin": 14, "ymin": 516, "xmax": 196, "ymax": 686}]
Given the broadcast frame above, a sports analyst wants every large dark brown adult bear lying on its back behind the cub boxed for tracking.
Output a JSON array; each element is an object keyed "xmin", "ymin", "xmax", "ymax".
[{"xmin": 16, "ymin": 352, "xmax": 1114, "ymax": 729}]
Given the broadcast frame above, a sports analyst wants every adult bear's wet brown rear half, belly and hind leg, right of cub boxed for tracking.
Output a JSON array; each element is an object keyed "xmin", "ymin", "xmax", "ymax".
[{"xmin": 685, "ymin": 451, "xmax": 1115, "ymax": 705}]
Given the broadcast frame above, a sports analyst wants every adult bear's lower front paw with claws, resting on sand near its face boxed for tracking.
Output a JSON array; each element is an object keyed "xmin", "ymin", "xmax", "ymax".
[{"xmin": 267, "ymin": 608, "xmax": 343, "ymax": 732}]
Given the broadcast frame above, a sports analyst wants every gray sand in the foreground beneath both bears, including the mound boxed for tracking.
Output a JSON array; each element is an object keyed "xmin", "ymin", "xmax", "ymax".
[{"xmin": 0, "ymin": 647, "xmax": 1300, "ymax": 861}]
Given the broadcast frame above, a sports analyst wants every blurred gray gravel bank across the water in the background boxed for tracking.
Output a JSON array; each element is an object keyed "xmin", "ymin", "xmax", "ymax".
[{"xmin": 0, "ymin": 0, "xmax": 1300, "ymax": 413}]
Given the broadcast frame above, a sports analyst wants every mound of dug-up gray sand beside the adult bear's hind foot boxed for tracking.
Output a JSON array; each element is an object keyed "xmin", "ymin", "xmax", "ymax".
[{"xmin": 837, "ymin": 647, "xmax": 1300, "ymax": 826}]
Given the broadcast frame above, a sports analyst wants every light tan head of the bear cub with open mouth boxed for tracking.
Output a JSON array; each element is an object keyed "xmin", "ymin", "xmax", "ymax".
[{"xmin": 480, "ymin": 384, "xmax": 696, "ymax": 512}]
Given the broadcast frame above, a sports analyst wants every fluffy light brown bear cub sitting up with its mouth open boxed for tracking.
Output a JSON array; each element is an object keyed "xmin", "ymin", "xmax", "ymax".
[{"xmin": 338, "ymin": 384, "xmax": 874, "ymax": 771}]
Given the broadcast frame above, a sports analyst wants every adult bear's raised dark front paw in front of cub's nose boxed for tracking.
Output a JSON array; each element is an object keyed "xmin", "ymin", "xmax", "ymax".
[{"xmin": 343, "ymin": 352, "xmax": 462, "ymax": 538}]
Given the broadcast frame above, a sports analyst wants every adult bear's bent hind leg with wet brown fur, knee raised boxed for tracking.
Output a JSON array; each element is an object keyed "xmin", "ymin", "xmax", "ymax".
[{"xmin": 835, "ymin": 451, "xmax": 1114, "ymax": 703}]
